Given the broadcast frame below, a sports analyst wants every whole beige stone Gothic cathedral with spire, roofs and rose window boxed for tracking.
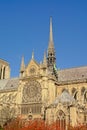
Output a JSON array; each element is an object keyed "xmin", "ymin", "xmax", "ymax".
[{"xmin": 0, "ymin": 18, "xmax": 87, "ymax": 129}]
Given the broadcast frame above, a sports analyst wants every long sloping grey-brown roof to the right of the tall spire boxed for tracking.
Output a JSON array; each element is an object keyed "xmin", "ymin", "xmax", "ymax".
[{"xmin": 58, "ymin": 66, "xmax": 87, "ymax": 82}]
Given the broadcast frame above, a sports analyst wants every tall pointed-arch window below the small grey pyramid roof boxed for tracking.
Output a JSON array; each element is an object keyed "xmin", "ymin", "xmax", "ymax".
[{"xmin": 56, "ymin": 110, "xmax": 66, "ymax": 130}]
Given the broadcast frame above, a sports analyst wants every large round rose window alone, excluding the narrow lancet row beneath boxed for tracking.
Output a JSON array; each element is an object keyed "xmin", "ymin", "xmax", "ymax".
[{"xmin": 23, "ymin": 81, "xmax": 41, "ymax": 103}]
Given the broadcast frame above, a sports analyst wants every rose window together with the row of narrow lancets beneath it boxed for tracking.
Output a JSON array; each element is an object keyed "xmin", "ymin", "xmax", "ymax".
[{"xmin": 21, "ymin": 80, "xmax": 42, "ymax": 114}]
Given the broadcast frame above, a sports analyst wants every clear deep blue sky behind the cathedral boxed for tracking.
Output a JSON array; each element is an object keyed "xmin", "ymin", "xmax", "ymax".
[{"xmin": 0, "ymin": 0, "xmax": 87, "ymax": 77}]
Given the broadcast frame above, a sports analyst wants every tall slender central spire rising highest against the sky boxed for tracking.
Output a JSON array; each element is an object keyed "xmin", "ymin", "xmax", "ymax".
[{"xmin": 47, "ymin": 17, "xmax": 56, "ymax": 73}]
